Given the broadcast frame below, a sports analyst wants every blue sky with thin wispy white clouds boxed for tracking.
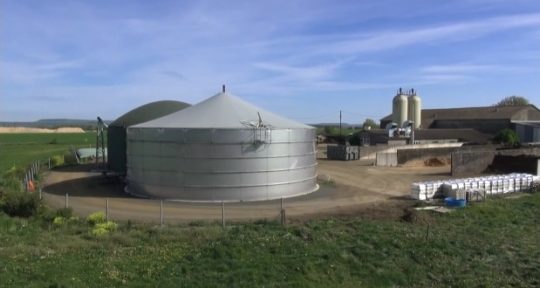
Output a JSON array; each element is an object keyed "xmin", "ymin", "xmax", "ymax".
[{"xmin": 0, "ymin": 0, "xmax": 540, "ymax": 123}]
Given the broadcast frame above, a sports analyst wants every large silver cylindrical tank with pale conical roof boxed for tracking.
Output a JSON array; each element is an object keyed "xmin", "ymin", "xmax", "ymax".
[{"xmin": 126, "ymin": 93, "xmax": 318, "ymax": 201}]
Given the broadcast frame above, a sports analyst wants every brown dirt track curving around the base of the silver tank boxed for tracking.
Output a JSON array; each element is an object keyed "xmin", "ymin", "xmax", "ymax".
[{"xmin": 44, "ymin": 159, "xmax": 450, "ymax": 222}]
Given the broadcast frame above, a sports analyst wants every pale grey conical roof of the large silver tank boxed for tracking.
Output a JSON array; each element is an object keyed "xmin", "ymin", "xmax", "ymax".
[{"xmin": 131, "ymin": 93, "xmax": 313, "ymax": 129}]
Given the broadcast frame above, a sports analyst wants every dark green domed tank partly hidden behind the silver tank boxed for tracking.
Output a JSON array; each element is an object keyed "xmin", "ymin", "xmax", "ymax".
[{"xmin": 107, "ymin": 100, "xmax": 190, "ymax": 175}]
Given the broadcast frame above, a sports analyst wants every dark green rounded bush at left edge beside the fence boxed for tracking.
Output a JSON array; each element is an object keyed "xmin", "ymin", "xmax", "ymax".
[{"xmin": 0, "ymin": 191, "xmax": 39, "ymax": 217}]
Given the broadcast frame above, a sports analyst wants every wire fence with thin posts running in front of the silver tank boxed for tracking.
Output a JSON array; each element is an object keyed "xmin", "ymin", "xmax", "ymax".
[{"xmin": 41, "ymin": 192, "xmax": 294, "ymax": 226}]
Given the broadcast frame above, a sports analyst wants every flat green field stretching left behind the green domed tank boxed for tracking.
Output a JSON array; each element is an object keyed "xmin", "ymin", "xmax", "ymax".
[{"xmin": 0, "ymin": 132, "xmax": 96, "ymax": 172}]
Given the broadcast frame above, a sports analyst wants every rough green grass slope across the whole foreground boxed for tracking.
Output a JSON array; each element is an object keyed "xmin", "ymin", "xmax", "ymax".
[{"xmin": 0, "ymin": 193, "xmax": 540, "ymax": 287}]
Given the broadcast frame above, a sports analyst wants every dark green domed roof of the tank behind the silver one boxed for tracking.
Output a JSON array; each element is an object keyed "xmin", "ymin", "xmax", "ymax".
[{"xmin": 109, "ymin": 100, "xmax": 191, "ymax": 127}]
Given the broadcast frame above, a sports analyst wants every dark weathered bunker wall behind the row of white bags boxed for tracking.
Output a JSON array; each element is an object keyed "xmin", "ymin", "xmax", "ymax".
[{"xmin": 452, "ymin": 148, "xmax": 540, "ymax": 177}]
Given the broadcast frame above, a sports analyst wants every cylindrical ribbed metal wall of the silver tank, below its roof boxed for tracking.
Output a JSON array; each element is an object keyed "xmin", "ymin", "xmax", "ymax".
[{"xmin": 127, "ymin": 127, "xmax": 318, "ymax": 201}]
